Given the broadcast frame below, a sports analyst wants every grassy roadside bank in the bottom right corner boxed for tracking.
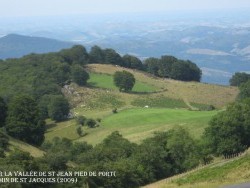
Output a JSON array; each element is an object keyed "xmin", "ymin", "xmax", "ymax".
[{"xmin": 145, "ymin": 150, "xmax": 250, "ymax": 188}]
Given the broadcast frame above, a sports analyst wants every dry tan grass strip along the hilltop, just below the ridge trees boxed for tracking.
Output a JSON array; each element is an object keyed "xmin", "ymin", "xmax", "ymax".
[{"xmin": 84, "ymin": 64, "xmax": 238, "ymax": 108}]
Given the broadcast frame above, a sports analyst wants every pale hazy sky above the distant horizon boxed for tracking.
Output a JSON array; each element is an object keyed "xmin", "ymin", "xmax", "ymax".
[{"xmin": 0, "ymin": 0, "xmax": 250, "ymax": 17}]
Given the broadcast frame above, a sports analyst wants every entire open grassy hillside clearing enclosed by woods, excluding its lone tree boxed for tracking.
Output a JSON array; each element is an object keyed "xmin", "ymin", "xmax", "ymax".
[{"xmin": 45, "ymin": 64, "xmax": 238, "ymax": 144}]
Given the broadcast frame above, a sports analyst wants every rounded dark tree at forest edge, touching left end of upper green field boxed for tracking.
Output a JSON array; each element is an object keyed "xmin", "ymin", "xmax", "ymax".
[{"xmin": 71, "ymin": 65, "xmax": 89, "ymax": 86}]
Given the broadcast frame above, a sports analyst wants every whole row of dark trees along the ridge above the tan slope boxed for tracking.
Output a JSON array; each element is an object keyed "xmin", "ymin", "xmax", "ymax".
[{"xmin": 89, "ymin": 46, "xmax": 202, "ymax": 82}]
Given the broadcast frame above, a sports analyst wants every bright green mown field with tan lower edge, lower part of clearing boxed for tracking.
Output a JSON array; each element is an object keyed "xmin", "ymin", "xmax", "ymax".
[{"xmin": 46, "ymin": 108, "xmax": 218, "ymax": 145}]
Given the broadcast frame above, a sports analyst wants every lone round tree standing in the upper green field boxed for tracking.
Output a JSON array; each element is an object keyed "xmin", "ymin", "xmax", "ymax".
[{"xmin": 114, "ymin": 71, "xmax": 135, "ymax": 92}]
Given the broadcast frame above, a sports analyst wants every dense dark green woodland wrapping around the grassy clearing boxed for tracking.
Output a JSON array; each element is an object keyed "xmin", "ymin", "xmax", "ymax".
[{"xmin": 0, "ymin": 46, "xmax": 250, "ymax": 188}]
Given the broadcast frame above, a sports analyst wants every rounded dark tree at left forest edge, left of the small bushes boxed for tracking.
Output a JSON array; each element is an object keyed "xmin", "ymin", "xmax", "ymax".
[{"xmin": 48, "ymin": 95, "xmax": 70, "ymax": 121}]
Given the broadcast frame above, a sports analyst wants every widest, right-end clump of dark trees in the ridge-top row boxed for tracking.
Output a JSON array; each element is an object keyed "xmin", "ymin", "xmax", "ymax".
[{"xmin": 145, "ymin": 56, "xmax": 201, "ymax": 82}]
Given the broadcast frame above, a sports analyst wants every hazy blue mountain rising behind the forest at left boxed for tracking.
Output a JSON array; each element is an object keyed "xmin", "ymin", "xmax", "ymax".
[{"xmin": 0, "ymin": 34, "xmax": 73, "ymax": 59}]
